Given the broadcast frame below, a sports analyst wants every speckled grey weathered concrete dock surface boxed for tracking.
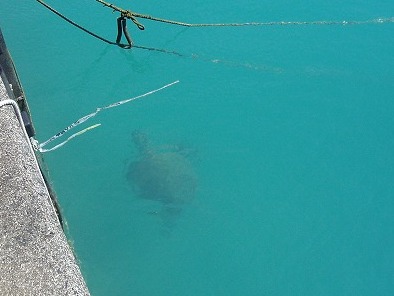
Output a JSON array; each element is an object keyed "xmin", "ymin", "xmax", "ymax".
[{"xmin": 0, "ymin": 75, "xmax": 89, "ymax": 295}]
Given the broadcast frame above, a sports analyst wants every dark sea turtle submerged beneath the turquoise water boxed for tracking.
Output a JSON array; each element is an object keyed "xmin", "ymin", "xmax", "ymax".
[{"xmin": 127, "ymin": 131, "xmax": 197, "ymax": 212}]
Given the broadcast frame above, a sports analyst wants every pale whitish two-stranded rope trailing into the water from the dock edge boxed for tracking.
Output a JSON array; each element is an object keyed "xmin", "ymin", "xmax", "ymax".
[{"xmin": 36, "ymin": 80, "xmax": 179, "ymax": 152}]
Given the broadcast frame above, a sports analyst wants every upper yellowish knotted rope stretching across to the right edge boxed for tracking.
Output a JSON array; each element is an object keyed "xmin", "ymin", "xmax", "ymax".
[{"xmin": 96, "ymin": 0, "xmax": 394, "ymax": 30}]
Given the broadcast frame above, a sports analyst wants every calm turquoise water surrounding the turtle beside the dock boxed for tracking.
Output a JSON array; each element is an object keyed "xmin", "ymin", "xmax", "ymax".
[{"xmin": 0, "ymin": 0, "xmax": 394, "ymax": 296}]
